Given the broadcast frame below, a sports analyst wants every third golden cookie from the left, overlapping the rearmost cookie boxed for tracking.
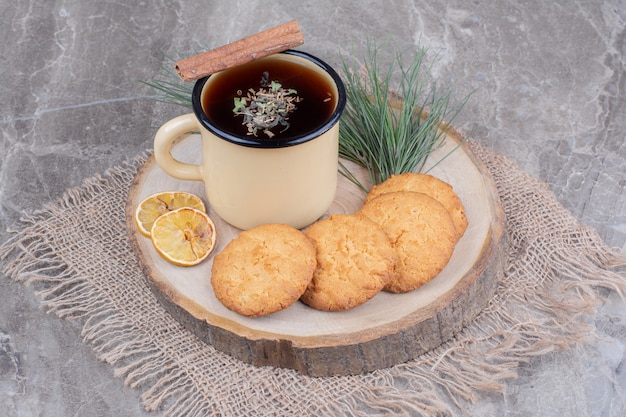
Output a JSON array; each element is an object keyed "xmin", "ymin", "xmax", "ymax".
[{"xmin": 359, "ymin": 191, "xmax": 457, "ymax": 293}]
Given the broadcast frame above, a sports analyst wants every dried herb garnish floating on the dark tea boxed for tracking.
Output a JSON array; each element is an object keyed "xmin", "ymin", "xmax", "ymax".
[{"xmin": 233, "ymin": 71, "xmax": 303, "ymax": 138}]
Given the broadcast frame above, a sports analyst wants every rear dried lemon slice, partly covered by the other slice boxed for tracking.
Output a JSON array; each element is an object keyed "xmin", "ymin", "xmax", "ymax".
[{"xmin": 135, "ymin": 191, "xmax": 206, "ymax": 237}]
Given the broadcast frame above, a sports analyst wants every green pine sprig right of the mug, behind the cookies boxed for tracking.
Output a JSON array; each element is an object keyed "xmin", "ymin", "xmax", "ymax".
[{"xmin": 339, "ymin": 44, "xmax": 470, "ymax": 189}]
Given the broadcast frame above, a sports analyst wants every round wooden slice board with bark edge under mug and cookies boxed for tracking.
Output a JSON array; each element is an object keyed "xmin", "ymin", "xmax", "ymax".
[{"xmin": 126, "ymin": 130, "xmax": 506, "ymax": 376}]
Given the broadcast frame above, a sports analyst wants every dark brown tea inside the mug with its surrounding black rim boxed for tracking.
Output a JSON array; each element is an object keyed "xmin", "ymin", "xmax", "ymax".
[{"xmin": 192, "ymin": 50, "xmax": 346, "ymax": 148}]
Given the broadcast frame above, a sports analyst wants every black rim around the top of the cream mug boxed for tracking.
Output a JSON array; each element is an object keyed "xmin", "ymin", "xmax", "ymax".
[{"xmin": 191, "ymin": 49, "xmax": 347, "ymax": 148}]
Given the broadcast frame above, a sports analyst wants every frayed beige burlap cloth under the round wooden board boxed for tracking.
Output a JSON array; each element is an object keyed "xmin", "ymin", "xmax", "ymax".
[{"xmin": 0, "ymin": 140, "xmax": 626, "ymax": 416}]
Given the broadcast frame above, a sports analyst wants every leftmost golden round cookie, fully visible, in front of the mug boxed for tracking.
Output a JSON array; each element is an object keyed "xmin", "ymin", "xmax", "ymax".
[{"xmin": 211, "ymin": 224, "xmax": 317, "ymax": 317}]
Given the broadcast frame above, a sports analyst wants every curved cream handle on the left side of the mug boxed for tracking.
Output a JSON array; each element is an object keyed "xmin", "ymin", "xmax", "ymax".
[{"xmin": 154, "ymin": 113, "xmax": 202, "ymax": 181}]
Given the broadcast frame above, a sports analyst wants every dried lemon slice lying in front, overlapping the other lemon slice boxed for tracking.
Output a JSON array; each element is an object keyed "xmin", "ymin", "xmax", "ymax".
[{"xmin": 150, "ymin": 207, "xmax": 216, "ymax": 266}]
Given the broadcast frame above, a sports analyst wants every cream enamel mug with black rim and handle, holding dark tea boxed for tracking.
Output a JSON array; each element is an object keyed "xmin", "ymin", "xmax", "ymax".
[{"xmin": 154, "ymin": 51, "xmax": 346, "ymax": 229}]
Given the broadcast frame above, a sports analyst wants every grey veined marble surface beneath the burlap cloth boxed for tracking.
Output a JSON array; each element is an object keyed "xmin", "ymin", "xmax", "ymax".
[{"xmin": 0, "ymin": 0, "xmax": 626, "ymax": 417}]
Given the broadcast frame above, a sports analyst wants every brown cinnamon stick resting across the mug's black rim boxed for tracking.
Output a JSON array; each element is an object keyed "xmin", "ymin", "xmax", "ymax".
[{"xmin": 175, "ymin": 20, "xmax": 304, "ymax": 81}]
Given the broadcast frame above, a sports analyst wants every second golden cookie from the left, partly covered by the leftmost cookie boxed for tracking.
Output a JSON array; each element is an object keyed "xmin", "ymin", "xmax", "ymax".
[{"xmin": 300, "ymin": 214, "xmax": 395, "ymax": 311}]
